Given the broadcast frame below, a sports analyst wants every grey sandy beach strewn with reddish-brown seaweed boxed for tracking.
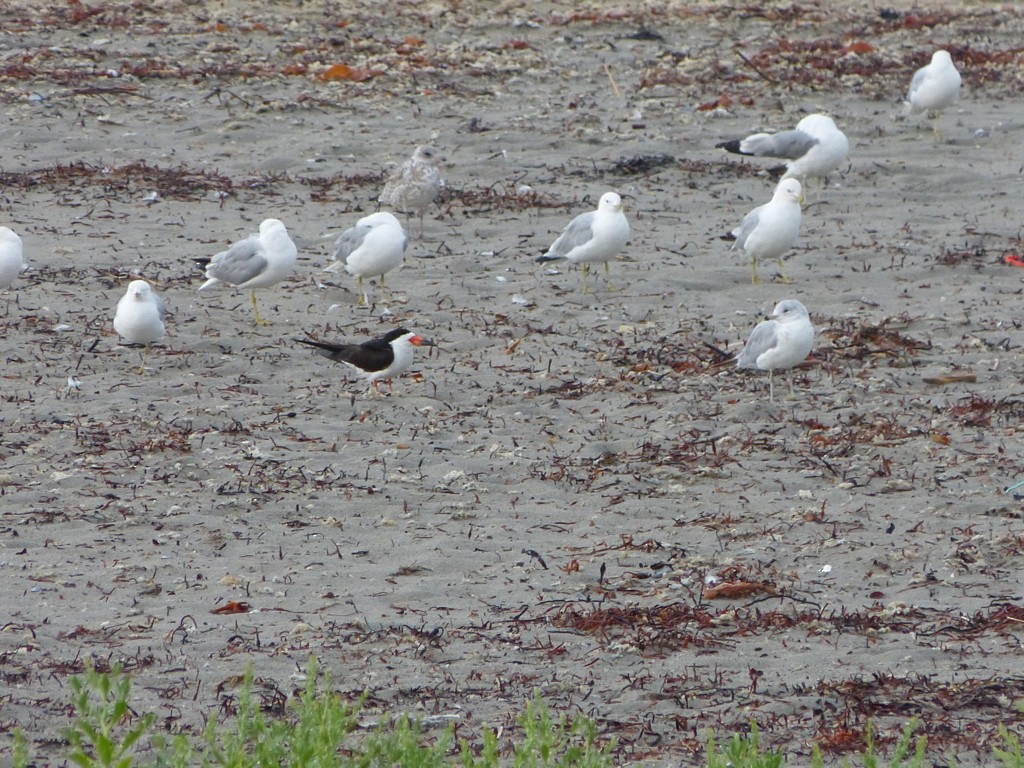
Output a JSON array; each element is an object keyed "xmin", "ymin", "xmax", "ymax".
[{"xmin": 0, "ymin": 0, "xmax": 1024, "ymax": 766}]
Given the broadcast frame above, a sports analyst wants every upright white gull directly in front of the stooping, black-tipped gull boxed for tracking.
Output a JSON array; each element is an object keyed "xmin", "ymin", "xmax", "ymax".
[{"xmin": 730, "ymin": 178, "xmax": 804, "ymax": 283}]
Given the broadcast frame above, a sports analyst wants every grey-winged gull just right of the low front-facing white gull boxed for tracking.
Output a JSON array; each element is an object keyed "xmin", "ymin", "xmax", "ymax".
[{"xmin": 197, "ymin": 219, "xmax": 298, "ymax": 326}]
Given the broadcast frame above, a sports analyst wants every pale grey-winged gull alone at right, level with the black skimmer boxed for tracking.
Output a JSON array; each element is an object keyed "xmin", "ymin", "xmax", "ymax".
[{"xmin": 736, "ymin": 299, "xmax": 814, "ymax": 401}]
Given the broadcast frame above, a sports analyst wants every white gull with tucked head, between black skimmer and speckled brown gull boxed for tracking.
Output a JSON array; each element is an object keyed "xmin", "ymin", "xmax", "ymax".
[{"xmin": 324, "ymin": 211, "xmax": 409, "ymax": 305}]
